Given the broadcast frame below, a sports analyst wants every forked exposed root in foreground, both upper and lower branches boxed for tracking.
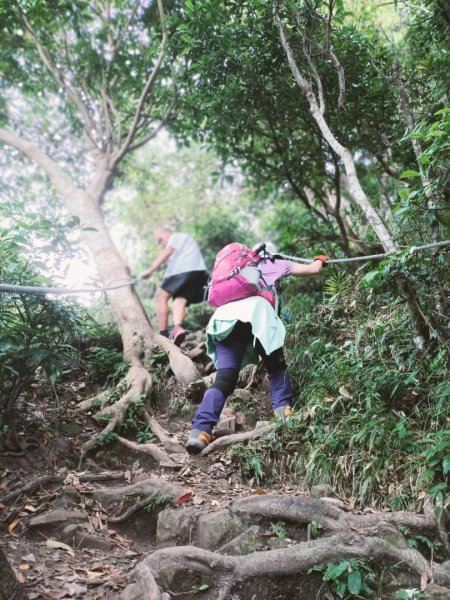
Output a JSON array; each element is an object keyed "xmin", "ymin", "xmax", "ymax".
[{"xmin": 116, "ymin": 494, "xmax": 450, "ymax": 600}]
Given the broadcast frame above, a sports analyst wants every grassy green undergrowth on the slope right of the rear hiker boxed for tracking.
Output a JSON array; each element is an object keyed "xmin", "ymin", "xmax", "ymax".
[{"xmin": 233, "ymin": 253, "xmax": 450, "ymax": 510}]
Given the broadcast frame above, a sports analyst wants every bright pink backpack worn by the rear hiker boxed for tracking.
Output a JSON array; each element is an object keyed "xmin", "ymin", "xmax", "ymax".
[{"xmin": 208, "ymin": 242, "xmax": 276, "ymax": 308}]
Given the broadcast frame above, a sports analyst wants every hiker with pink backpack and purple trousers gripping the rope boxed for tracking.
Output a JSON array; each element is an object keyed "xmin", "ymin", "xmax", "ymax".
[{"xmin": 186, "ymin": 243, "xmax": 328, "ymax": 454}]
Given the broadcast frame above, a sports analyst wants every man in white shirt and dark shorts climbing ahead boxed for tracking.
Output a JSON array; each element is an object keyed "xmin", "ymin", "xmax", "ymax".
[{"xmin": 141, "ymin": 226, "xmax": 209, "ymax": 346}]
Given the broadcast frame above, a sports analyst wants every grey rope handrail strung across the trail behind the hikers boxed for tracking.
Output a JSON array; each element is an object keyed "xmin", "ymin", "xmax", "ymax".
[{"xmin": 0, "ymin": 240, "xmax": 450, "ymax": 295}]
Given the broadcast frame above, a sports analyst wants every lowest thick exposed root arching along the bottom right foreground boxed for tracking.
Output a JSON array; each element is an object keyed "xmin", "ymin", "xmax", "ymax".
[{"xmin": 120, "ymin": 533, "xmax": 450, "ymax": 600}]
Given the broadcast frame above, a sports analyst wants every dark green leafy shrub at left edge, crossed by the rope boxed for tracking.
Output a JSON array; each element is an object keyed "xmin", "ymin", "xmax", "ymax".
[{"xmin": 0, "ymin": 230, "xmax": 83, "ymax": 419}]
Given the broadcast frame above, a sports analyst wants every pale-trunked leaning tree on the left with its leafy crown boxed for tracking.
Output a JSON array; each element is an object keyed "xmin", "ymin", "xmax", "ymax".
[{"xmin": 0, "ymin": 0, "xmax": 198, "ymax": 453}]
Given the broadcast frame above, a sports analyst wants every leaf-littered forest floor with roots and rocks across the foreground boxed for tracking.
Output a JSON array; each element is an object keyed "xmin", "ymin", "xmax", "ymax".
[{"xmin": 0, "ymin": 332, "xmax": 450, "ymax": 600}]
